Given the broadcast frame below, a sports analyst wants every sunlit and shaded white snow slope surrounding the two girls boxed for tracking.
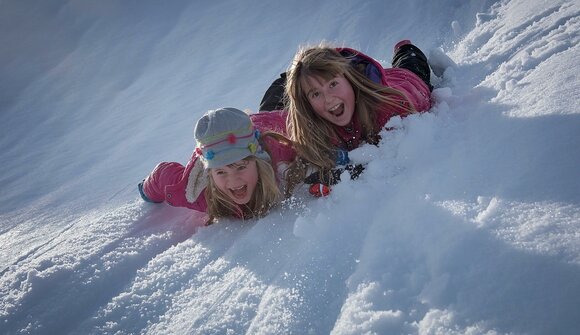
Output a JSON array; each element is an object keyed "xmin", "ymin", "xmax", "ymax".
[{"xmin": 0, "ymin": 0, "xmax": 580, "ymax": 334}]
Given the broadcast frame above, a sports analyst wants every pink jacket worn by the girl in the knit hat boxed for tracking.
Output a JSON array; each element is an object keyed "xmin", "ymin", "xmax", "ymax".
[{"xmin": 143, "ymin": 111, "xmax": 296, "ymax": 212}]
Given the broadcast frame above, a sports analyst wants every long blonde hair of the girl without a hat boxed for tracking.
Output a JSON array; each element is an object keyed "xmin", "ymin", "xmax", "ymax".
[{"xmin": 286, "ymin": 42, "xmax": 413, "ymax": 192}]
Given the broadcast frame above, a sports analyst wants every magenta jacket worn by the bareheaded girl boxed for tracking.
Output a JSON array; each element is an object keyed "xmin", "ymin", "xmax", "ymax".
[{"xmin": 335, "ymin": 48, "xmax": 431, "ymax": 151}]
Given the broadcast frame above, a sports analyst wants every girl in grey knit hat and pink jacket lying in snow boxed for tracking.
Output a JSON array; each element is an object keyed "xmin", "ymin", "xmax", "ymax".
[{"xmin": 139, "ymin": 108, "xmax": 295, "ymax": 224}]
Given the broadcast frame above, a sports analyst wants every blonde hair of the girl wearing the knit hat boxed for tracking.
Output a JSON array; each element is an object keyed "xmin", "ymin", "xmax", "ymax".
[{"xmin": 205, "ymin": 135, "xmax": 282, "ymax": 224}]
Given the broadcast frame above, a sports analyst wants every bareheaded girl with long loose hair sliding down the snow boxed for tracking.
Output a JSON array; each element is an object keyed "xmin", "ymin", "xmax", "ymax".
[{"xmin": 260, "ymin": 40, "xmax": 432, "ymax": 196}]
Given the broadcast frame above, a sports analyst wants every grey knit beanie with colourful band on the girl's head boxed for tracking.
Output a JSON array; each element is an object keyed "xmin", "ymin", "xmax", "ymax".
[{"xmin": 194, "ymin": 107, "xmax": 269, "ymax": 168}]
